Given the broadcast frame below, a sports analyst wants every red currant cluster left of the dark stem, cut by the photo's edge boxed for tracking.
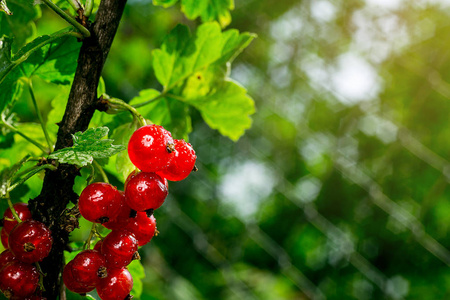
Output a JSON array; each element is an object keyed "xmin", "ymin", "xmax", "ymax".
[{"xmin": 0, "ymin": 203, "xmax": 53, "ymax": 300}]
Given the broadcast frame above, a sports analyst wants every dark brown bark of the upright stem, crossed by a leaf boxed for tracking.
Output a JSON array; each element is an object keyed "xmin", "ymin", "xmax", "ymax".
[{"xmin": 29, "ymin": 0, "xmax": 126, "ymax": 299}]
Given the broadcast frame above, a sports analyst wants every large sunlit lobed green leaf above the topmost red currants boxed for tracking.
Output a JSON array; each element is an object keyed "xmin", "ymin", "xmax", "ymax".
[{"xmin": 151, "ymin": 23, "xmax": 255, "ymax": 140}]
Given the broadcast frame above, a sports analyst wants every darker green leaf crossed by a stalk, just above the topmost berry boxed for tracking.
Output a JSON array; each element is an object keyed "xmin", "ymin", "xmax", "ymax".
[{"xmin": 130, "ymin": 89, "xmax": 192, "ymax": 140}]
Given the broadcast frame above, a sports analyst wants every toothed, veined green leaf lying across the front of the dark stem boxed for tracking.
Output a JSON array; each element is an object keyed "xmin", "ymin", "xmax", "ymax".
[{"xmin": 49, "ymin": 127, "xmax": 126, "ymax": 167}]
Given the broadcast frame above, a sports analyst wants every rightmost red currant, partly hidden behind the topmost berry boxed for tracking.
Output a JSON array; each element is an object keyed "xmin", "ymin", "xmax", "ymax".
[{"xmin": 157, "ymin": 140, "xmax": 197, "ymax": 181}]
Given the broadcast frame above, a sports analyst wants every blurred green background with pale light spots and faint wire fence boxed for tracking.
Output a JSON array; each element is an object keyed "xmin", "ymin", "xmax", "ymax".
[{"xmin": 0, "ymin": 0, "xmax": 450, "ymax": 300}]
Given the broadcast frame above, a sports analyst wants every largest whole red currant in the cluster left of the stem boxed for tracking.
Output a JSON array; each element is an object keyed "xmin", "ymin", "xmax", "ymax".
[{"xmin": 9, "ymin": 220, "xmax": 53, "ymax": 263}]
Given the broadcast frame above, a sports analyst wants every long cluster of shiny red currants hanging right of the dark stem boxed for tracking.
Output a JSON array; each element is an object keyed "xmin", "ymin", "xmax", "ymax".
[{"xmin": 63, "ymin": 125, "xmax": 196, "ymax": 300}]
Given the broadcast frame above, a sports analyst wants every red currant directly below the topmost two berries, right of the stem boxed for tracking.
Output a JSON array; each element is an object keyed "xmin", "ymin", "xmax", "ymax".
[{"xmin": 125, "ymin": 172, "xmax": 169, "ymax": 211}]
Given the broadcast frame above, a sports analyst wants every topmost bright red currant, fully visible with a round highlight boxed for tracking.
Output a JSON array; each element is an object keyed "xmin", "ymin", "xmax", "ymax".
[{"xmin": 128, "ymin": 125, "xmax": 173, "ymax": 172}]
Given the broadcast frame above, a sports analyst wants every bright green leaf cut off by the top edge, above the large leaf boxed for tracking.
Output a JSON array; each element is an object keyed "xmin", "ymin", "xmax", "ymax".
[{"xmin": 153, "ymin": 0, "xmax": 234, "ymax": 27}]
